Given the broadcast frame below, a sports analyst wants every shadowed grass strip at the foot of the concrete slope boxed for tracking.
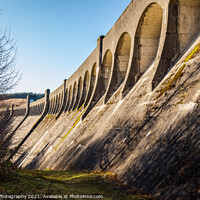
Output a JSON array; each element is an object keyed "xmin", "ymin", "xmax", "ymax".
[{"xmin": 0, "ymin": 170, "xmax": 153, "ymax": 200}]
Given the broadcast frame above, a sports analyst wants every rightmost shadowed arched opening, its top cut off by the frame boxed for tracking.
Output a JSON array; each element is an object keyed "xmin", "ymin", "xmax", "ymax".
[{"xmin": 152, "ymin": 0, "xmax": 200, "ymax": 89}]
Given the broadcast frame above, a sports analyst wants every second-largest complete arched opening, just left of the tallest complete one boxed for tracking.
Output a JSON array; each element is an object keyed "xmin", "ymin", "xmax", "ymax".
[{"xmin": 105, "ymin": 32, "xmax": 131, "ymax": 102}]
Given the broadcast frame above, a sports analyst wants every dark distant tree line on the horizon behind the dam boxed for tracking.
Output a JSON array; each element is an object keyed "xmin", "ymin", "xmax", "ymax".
[{"xmin": 6, "ymin": 92, "xmax": 44, "ymax": 101}]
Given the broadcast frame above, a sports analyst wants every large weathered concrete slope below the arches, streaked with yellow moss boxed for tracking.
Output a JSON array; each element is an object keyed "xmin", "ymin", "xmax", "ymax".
[{"xmin": 7, "ymin": 40, "xmax": 200, "ymax": 199}]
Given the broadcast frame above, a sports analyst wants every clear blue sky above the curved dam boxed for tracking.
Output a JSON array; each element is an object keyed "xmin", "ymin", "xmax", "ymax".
[{"xmin": 0, "ymin": 0, "xmax": 131, "ymax": 93}]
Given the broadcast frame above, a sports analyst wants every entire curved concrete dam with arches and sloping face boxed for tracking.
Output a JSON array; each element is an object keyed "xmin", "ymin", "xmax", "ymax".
[{"xmin": 5, "ymin": 0, "xmax": 200, "ymax": 199}]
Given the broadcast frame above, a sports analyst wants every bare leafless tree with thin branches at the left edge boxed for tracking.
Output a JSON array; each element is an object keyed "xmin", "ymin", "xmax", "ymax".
[{"xmin": 0, "ymin": 27, "xmax": 20, "ymax": 162}]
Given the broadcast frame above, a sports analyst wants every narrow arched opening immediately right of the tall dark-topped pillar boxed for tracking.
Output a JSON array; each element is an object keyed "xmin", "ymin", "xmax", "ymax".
[{"xmin": 99, "ymin": 50, "xmax": 112, "ymax": 96}]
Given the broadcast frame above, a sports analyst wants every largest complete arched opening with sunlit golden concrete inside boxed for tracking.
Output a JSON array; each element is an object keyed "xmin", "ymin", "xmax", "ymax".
[{"xmin": 123, "ymin": 3, "xmax": 163, "ymax": 95}]
